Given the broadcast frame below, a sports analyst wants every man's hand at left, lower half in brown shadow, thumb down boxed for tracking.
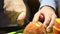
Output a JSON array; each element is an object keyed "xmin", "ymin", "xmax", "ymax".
[{"xmin": 4, "ymin": 0, "xmax": 26, "ymax": 23}]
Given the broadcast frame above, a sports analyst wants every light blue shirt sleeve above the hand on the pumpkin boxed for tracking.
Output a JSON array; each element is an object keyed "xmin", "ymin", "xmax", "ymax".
[{"xmin": 39, "ymin": 0, "xmax": 56, "ymax": 9}]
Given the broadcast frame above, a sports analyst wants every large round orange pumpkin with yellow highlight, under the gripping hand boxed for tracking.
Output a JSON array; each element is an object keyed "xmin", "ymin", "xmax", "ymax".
[{"xmin": 24, "ymin": 22, "xmax": 45, "ymax": 34}]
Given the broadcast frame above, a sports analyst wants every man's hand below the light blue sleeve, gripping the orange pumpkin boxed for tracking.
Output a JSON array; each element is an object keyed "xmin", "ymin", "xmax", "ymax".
[{"xmin": 33, "ymin": 6, "xmax": 56, "ymax": 29}]
